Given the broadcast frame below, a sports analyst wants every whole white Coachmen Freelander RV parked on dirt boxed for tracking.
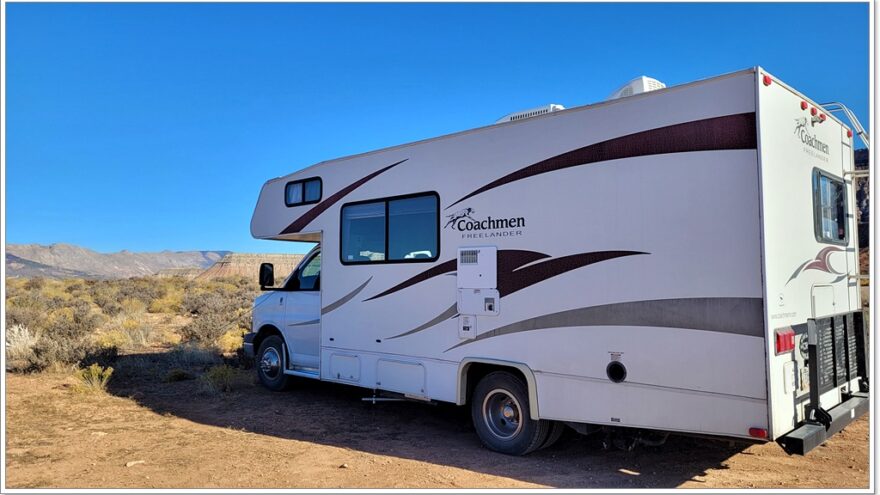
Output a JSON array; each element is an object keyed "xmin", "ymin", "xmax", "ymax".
[{"xmin": 246, "ymin": 68, "xmax": 869, "ymax": 454}]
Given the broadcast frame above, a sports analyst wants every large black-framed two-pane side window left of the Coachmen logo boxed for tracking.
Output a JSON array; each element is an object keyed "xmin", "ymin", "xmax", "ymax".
[{"xmin": 340, "ymin": 193, "xmax": 440, "ymax": 264}]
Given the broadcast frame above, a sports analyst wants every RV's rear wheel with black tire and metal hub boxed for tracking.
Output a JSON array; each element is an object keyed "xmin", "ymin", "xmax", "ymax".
[{"xmin": 471, "ymin": 371, "xmax": 551, "ymax": 455}]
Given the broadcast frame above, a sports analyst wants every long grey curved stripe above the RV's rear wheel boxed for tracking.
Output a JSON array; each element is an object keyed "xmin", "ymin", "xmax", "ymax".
[{"xmin": 444, "ymin": 297, "xmax": 764, "ymax": 352}]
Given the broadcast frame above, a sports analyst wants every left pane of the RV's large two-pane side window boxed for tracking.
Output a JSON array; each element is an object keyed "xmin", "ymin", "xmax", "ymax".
[{"xmin": 342, "ymin": 201, "xmax": 385, "ymax": 262}]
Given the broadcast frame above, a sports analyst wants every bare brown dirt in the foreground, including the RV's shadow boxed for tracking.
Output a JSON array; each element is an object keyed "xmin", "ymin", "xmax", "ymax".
[{"xmin": 6, "ymin": 366, "xmax": 869, "ymax": 488}]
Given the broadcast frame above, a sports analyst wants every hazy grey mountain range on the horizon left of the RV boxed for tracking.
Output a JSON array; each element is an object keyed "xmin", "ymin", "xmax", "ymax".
[{"xmin": 6, "ymin": 244, "xmax": 230, "ymax": 278}]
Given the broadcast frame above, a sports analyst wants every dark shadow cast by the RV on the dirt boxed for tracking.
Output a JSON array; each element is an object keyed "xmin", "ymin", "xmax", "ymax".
[{"xmin": 110, "ymin": 355, "xmax": 748, "ymax": 488}]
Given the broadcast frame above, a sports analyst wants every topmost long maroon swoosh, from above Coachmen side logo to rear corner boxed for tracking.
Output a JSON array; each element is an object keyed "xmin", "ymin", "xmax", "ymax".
[{"xmin": 446, "ymin": 112, "xmax": 758, "ymax": 209}]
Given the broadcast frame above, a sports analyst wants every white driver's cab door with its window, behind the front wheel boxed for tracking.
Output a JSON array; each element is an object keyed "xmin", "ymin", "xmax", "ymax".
[{"xmin": 284, "ymin": 250, "xmax": 321, "ymax": 375}]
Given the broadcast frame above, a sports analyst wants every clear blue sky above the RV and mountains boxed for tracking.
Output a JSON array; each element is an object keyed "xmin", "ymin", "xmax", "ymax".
[{"xmin": 5, "ymin": 3, "xmax": 869, "ymax": 252}]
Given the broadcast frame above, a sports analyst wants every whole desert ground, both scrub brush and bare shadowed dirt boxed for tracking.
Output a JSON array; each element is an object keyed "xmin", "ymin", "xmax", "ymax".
[{"xmin": 4, "ymin": 277, "xmax": 870, "ymax": 488}]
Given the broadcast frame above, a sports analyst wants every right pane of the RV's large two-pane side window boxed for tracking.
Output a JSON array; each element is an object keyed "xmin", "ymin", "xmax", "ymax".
[{"xmin": 388, "ymin": 195, "xmax": 437, "ymax": 260}]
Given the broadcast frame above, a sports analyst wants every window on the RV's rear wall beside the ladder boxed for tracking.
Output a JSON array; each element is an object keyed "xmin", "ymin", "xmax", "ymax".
[{"xmin": 813, "ymin": 170, "xmax": 849, "ymax": 244}]
